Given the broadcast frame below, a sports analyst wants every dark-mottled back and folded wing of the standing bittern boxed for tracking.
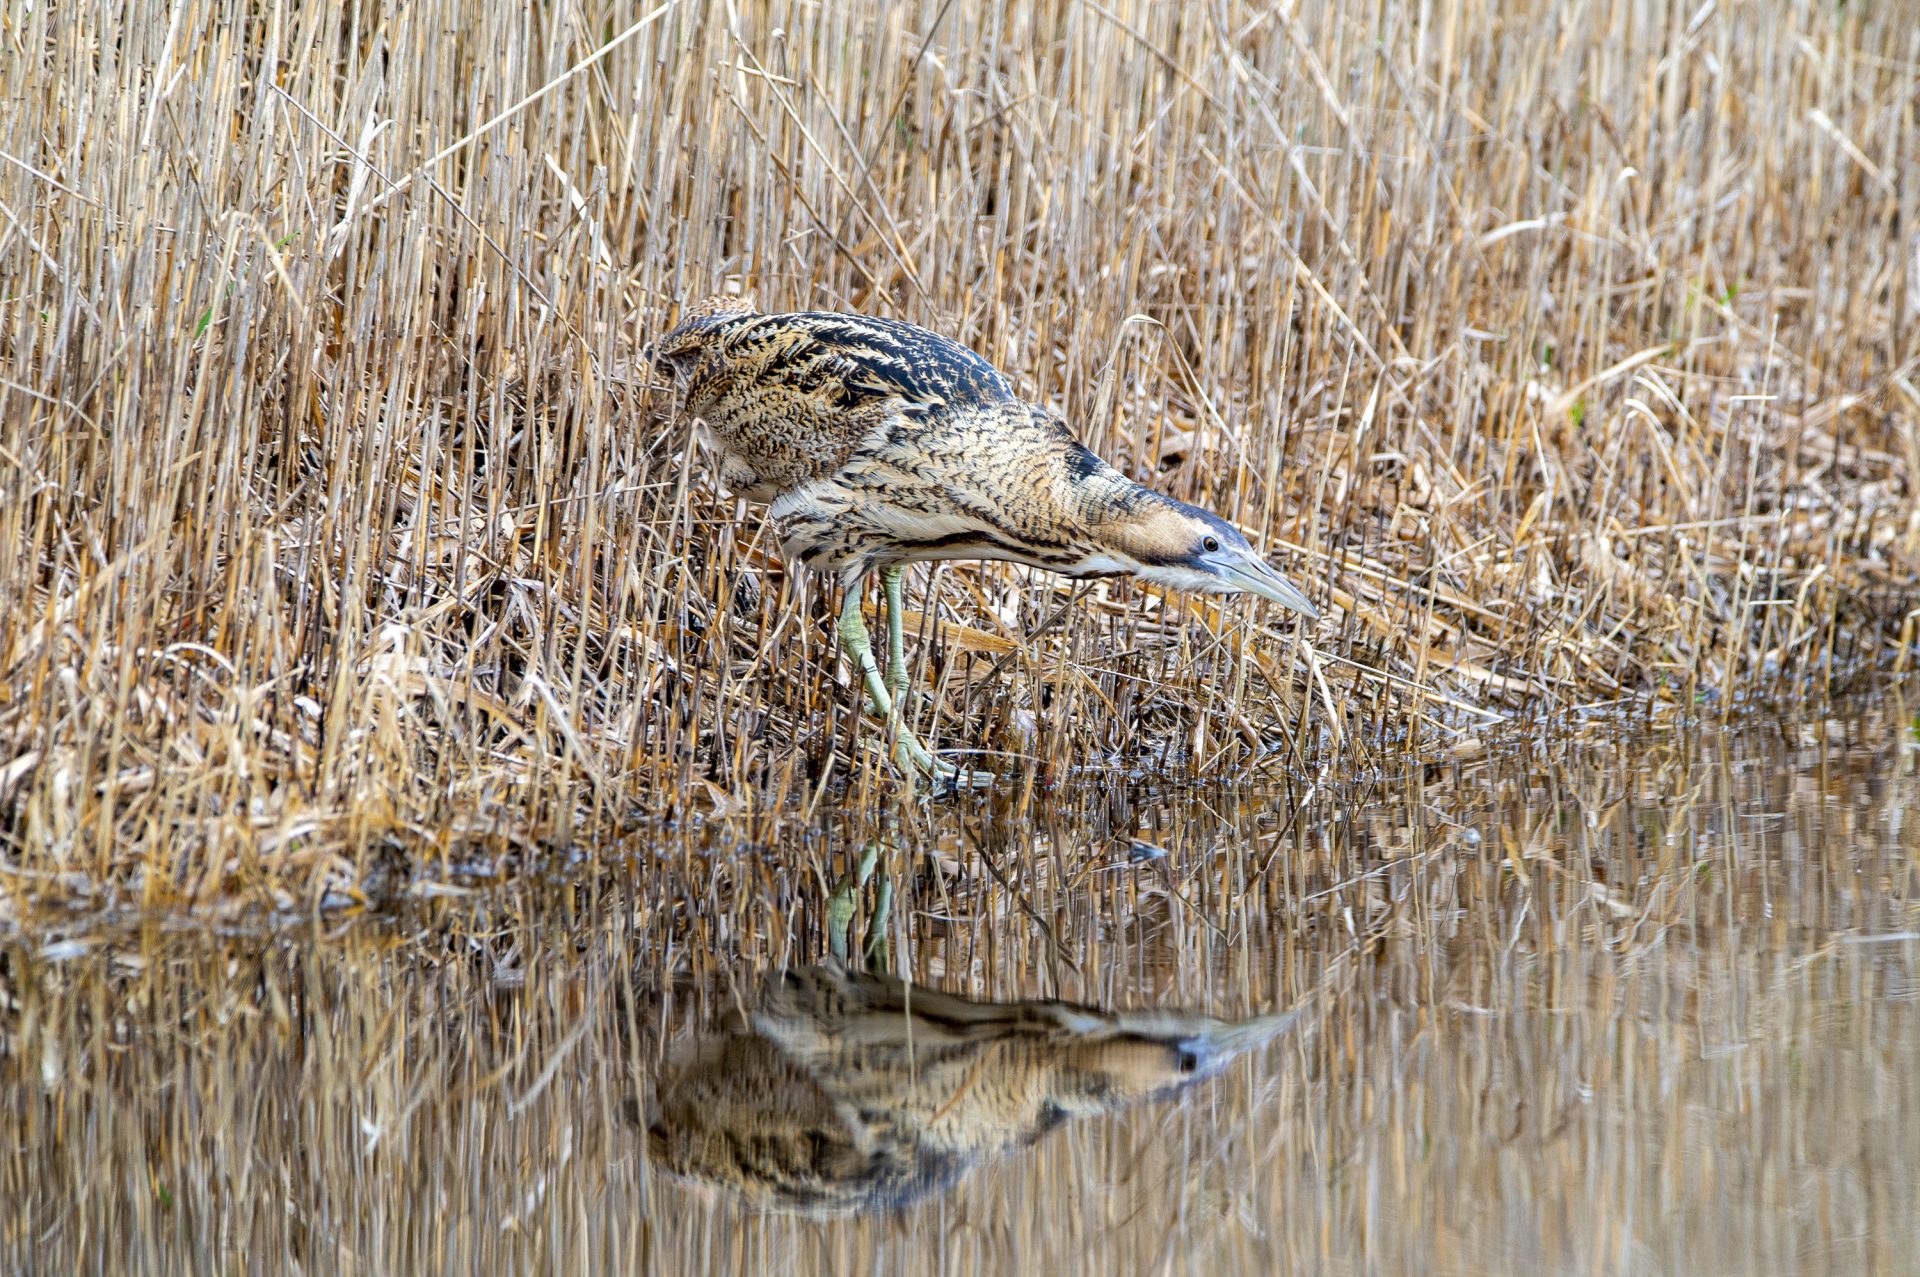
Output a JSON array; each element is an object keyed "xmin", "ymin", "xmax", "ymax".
[{"xmin": 657, "ymin": 298, "xmax": 1014, "ymax": 499}]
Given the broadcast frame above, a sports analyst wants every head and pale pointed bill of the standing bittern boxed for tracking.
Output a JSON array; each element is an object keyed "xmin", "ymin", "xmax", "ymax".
[{"xmin": 1102, "ymin": 494, "xmax": 1319, "ymax": 620}]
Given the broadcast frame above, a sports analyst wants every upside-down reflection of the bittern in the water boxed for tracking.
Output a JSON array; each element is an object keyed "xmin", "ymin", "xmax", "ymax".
[{"xmin": 645, "ymin": 841, "xmax": 1296, "ymax": 1214}]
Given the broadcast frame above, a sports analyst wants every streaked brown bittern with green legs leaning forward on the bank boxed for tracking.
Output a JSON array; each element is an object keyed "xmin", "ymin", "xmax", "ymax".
[{"xmin": 657, "ymin": 298, "xmax": 1317, "ymax": 780}]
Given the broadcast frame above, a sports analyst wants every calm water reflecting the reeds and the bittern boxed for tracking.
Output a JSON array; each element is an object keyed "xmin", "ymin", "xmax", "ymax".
[{"xmin": 0, "ymin": 705, "xmax": 1920, "ymax": 1273}]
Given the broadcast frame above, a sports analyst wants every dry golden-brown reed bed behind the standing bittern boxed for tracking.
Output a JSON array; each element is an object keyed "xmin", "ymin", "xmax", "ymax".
[{"xmin": 0, "ymin": 0, "xmax": 1920, "ymax": 916}]
